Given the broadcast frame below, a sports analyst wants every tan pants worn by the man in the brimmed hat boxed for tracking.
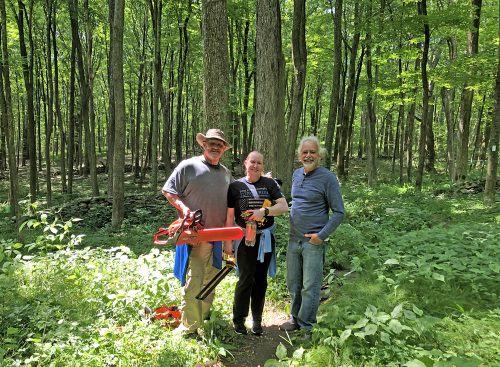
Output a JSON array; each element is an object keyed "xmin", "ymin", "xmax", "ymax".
[{"xmin": 181, "ymin": 242, "xmax": 219, "ymax": 331}]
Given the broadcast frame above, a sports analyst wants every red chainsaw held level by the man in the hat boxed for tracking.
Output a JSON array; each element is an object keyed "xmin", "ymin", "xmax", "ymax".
[{"xmin": 154, "ymin": 209, "xmax": 243, "ymax": 246}]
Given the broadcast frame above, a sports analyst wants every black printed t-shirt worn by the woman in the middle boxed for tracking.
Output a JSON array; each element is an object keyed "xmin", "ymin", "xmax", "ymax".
[{"xmin": 227, "ymin": 177, "xmax": 283, "ymax": 229}]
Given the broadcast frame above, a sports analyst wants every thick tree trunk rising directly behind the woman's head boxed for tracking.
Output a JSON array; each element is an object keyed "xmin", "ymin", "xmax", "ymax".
[{"xmin": 254, "ymin": 0, "xmax": 286, "ymax": 178}]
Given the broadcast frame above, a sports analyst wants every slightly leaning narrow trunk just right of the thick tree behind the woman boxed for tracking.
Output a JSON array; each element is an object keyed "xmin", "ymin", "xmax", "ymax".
[{"xmin": 282, "ymin": 0, "xmax": 307, "ymax": 196}]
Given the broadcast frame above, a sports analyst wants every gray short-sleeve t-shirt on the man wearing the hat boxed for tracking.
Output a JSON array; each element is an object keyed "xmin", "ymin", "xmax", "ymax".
[{"xmin": 163, "ymin": 156, "xmax": 232, "ymax": 228}]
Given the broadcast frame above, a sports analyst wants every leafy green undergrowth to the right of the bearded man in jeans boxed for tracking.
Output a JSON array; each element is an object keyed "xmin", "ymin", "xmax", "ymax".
[{"xmin": 266, "ymin": 185, "xmax": 500, "ymax": 367}]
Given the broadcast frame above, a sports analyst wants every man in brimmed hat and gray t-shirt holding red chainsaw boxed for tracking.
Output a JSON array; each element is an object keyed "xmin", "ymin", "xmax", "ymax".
[{"xmin": 162, "ymin": 129, "xmax": 232, "ymax": 334}]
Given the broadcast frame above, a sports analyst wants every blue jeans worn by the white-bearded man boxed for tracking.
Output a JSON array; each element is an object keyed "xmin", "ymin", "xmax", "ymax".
[{"xmin": 286, "ymin": 239, "xmax": 325, "ymax": 330}]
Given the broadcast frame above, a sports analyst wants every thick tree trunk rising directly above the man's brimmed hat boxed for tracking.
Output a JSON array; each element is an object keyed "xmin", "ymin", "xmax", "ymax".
[{"xmin": 202, "ymin": 0, "xmax": 232, "ymax": 145}]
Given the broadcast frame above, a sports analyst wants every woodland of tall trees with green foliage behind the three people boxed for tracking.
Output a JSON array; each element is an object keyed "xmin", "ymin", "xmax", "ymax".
[{"xmin": 0, "ymin": 0, "xmax": 499, "ymax": 227}]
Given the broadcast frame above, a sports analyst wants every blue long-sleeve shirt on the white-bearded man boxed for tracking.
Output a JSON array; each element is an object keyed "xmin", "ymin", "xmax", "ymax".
[{"xmin": 290, "ymin": 167, "xmax": 345, "ymax": 241}]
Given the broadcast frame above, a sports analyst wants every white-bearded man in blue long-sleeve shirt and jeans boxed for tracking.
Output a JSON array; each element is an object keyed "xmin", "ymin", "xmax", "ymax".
[{"xmin": 280, "ymin": 136, "xmax": 344, "ymax": 332}]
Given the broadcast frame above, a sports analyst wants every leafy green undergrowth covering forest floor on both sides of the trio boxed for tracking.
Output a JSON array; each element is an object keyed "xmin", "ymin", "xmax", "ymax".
[{"xmin": 0, "ymin": 174, "xmax": 500, "ymax": 367}]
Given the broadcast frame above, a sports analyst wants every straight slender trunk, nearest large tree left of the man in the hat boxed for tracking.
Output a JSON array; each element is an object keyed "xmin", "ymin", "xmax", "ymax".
[{"xmin": 111, "ymin": 0, "xmax": 125, "ymax": 229}]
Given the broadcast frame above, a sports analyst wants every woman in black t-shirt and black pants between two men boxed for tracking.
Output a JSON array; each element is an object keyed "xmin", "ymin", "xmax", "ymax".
[{"xmin": 224, "ymin": 151, "xmax": 288, "ymax": 335}]
